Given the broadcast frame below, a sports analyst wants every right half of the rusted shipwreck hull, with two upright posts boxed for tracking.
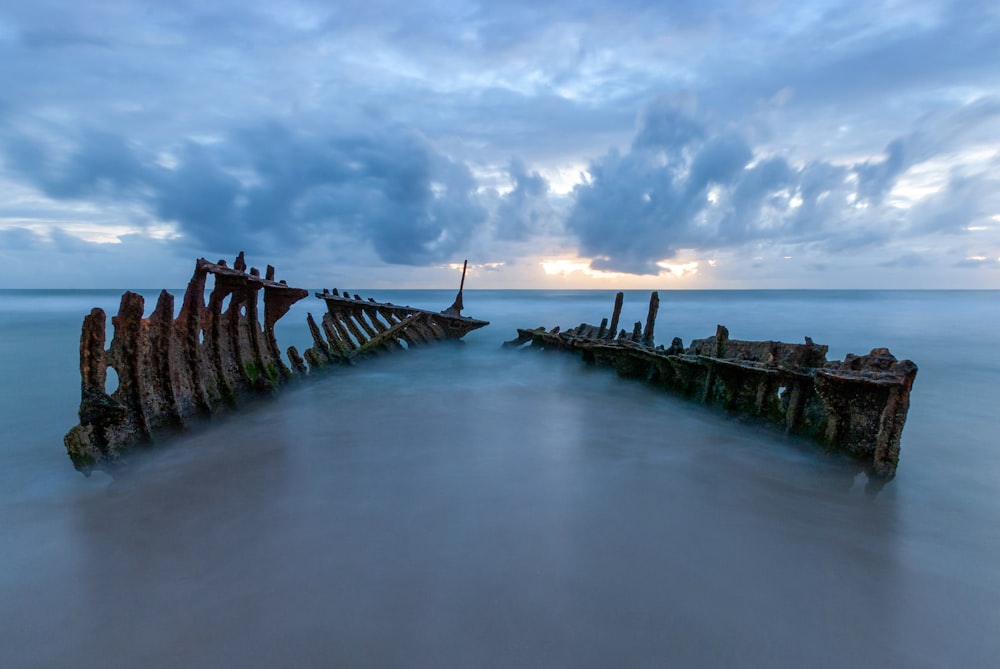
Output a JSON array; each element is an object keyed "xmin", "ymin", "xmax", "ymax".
[{"xmin": 504, "ymin": 292, "xmax": 917, "ymax": 481}]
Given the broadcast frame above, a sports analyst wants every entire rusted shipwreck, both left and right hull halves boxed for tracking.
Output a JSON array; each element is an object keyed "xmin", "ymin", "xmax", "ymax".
[{"xmin": 64, "ymin": 260, "xmax": 917, "ymax": 481}]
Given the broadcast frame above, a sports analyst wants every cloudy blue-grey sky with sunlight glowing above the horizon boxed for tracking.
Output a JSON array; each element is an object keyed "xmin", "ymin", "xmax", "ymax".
[{"xmin": 0, "ymin": 0, "xmax": 1000, "ymax": 289}]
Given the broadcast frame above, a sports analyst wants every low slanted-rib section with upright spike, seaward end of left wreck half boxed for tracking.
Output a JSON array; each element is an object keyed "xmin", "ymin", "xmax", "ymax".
[{"xmin": 306, "ymin": 261, "xmax": 489, "ymax": 364}]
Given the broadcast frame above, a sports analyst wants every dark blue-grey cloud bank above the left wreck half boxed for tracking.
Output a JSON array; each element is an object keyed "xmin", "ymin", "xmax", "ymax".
[{"xmin": 4, "ymin": 124, "xmax": 486, "ymax": 265}]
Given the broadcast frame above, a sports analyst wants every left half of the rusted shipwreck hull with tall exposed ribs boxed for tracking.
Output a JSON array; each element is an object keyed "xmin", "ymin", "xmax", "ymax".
[{"xmin": 64, "ymin": 252, "xmax": 489, "ymax": 473}]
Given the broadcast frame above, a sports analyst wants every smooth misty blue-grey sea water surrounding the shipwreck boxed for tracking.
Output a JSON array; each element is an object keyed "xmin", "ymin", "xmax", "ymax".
[{"xmin": 0, "ymin": 291, "xmax": 1000, "ymax": 667}]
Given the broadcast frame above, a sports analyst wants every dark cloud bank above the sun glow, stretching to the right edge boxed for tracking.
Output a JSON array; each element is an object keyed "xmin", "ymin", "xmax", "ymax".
[{"xmin": 566, "ymin": 96, "xmax": 997, "ymax": 274}]
